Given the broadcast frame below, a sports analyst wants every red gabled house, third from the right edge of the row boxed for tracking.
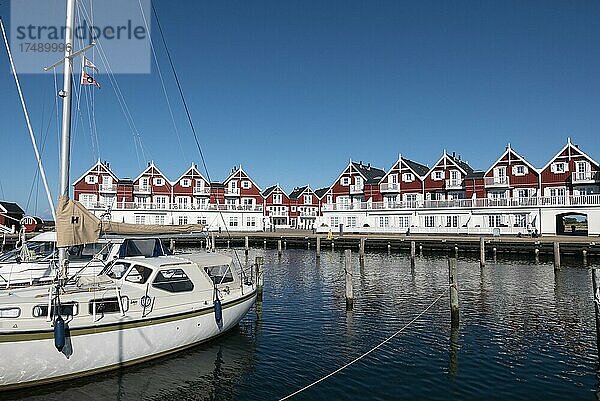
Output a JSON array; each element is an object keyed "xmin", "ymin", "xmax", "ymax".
[{"xmin": 424, "ymin": 150, "xmax": 474, "ymax": 200}]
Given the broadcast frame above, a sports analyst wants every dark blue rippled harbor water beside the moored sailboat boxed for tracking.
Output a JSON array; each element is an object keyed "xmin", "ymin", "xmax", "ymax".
[{"xmin": 5, "ymin": 249, "xmax": 599, "ymax": 401}]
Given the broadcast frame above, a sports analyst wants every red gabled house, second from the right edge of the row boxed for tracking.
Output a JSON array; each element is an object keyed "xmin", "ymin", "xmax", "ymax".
[{"xmin": 477, "ymin": 144, "xmax": 540, "ymax": 199}]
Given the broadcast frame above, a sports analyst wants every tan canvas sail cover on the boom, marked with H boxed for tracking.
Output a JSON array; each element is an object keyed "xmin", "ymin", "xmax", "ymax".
[{"xmin": 56, "ymin": 196, "xmax": 204, "ymax": 247}]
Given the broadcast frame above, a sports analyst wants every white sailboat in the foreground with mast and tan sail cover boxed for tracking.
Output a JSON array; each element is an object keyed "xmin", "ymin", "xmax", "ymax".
[{"xmin": 0, "ymin": 0, "xmax": 256, "ymax": 391}]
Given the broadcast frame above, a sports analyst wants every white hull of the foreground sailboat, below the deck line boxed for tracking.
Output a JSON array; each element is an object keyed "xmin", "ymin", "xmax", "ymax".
[{"xmin": 0, "ymin": 292, "xmax": 256, "ymax": 390}]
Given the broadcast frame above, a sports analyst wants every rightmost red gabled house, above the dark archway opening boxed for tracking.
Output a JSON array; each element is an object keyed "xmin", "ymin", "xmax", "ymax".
[{"xmin": 540, "ymin": 138, "xmax": 600, "ymax": 199}]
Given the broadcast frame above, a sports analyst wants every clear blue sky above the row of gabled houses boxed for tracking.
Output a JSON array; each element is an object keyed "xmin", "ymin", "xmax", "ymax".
[{"xmin": 0, "ymin": 0, "xmax": 600, "ymax": 219}]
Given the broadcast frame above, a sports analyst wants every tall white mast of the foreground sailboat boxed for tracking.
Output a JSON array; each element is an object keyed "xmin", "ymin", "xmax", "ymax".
[{"xmin": 58, "ymin": 0, "xmax": 75, "ymax": 278}]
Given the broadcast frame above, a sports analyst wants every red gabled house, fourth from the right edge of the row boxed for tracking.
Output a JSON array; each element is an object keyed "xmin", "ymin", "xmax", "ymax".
[{"xmin": 379, "ymin": 156, "xmax": 429, "ymax": 206}]
